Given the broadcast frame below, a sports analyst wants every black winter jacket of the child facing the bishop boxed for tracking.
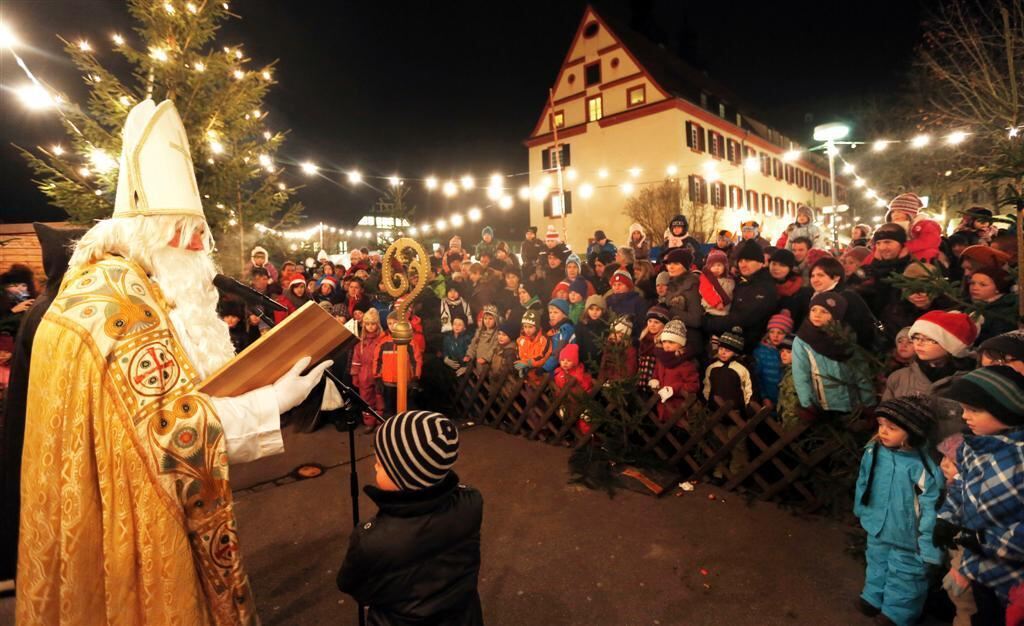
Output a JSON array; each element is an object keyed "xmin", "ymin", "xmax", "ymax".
[{"xmin": 338, "ymin": 472, "xmax": 483, "ymax": 626}]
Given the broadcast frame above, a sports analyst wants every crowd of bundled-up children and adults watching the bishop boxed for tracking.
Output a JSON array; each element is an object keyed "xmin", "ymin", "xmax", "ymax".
[{"xmin": 224, "ymin": 194, "xmax": 1024, "ymax": 624}]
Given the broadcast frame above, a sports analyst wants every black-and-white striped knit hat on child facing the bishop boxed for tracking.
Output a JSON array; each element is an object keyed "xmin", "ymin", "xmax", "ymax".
[{"xmin": 374, "ymin": 411, "xmax": 459, "ymax": 491}]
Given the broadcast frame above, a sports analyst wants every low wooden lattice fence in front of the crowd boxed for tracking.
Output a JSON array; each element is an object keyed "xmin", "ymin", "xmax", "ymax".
[{"xmin": 454, "ymin": 366, "xmax": 845, "ymax": 511}]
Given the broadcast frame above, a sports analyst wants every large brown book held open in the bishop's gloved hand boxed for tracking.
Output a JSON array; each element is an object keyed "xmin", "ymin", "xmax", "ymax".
[{"xmin": 199, "ymin": 302, "xmax": 356, "ymax": 398}]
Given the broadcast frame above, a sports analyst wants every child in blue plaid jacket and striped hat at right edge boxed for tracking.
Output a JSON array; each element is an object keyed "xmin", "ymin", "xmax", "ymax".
[{"xmin": 934, "ymin": 365, "xmax": 1024, "ymax": 624}]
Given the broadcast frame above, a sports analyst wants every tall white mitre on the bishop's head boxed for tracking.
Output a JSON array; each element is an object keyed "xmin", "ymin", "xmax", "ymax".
[{"xmin": 114, "ymin": 98, "xmax": 206, "ymax": 219}]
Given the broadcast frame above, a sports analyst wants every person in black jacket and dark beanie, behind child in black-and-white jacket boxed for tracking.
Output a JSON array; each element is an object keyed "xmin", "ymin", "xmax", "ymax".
[{"xmin": 705, "ymin": 239, "xmax": 778, "ymax": 350}]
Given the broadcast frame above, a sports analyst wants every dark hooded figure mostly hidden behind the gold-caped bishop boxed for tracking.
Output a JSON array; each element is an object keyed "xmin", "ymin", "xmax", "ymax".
[{"xmin": 0, "ymin": 223, "xmax": 86, "ymax": 581}]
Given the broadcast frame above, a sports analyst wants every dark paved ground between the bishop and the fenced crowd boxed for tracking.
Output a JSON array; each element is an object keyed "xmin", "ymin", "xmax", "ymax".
[{"xmin": 6, "ymin": 427, "xmax": 868, "ymax": 626}]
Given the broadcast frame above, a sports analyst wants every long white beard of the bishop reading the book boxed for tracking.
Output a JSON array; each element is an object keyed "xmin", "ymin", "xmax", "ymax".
[{"xmin": 152, "ymin": 246, "xmax": 234, "ymax": 379}]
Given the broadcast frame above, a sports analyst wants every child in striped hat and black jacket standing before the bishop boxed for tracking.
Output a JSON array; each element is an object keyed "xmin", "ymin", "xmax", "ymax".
[{"xmin": 338, "ymin": 411, "xmax": 483, "ymax": 624}]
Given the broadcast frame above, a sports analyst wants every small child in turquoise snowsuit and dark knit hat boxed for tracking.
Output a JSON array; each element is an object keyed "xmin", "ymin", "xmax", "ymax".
[{"xmin": 853, "ymin": 395, "xmax": 944, "ymax": 626}]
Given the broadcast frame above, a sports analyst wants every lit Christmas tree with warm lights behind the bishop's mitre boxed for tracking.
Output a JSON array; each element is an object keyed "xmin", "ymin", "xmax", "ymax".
[{"xmin": 22, "ymin": 0, "xmax": 302, "ymax": 273}]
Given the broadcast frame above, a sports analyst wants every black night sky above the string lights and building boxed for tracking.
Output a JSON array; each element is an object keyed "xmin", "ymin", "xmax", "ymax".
[{"xmin": 0, "ymin": 0, "xmax": 923, "ymax": 240}]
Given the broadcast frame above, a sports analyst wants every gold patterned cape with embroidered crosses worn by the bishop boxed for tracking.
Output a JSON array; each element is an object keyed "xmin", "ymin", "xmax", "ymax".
[{"xmin": 16, "ymin": 256, "xmax": 258, "ymax": 625}]
